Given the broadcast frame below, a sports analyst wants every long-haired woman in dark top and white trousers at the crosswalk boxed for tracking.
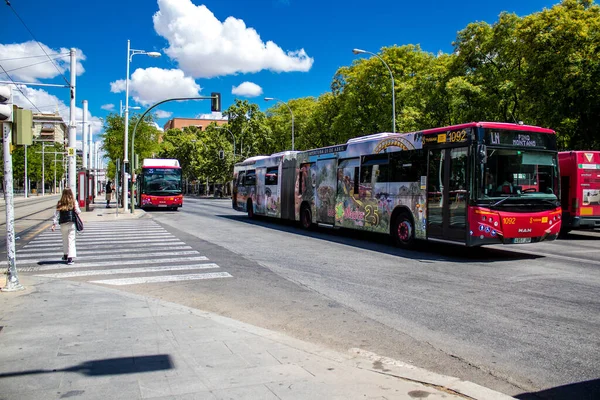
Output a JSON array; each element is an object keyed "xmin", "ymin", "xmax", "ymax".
[{"xmin": 52, "ymin": 188, "xmax": 81, "ymax": 265}]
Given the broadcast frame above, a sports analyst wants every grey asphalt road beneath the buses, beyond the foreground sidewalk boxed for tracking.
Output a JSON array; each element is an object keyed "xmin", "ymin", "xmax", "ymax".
[{"xmin": 142, "ymin": 199, "xmax": 600, "ymax": 395}]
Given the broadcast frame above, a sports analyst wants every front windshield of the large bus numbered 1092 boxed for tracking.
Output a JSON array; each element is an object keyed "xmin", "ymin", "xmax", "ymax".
[{"xmin": 474, "ymin": 147, "xmax": 559, "ymax": 205}]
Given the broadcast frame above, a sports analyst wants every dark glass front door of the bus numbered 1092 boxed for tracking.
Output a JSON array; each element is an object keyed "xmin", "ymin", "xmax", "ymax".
[{"xmin": 427, "ymin": 147, "xmax": 468, "ymax": 242}]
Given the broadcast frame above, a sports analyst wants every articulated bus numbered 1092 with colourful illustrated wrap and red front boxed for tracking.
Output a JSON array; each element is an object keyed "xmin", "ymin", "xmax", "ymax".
[{"xmin": 233, "ymin": 122, "xmax": 561, "ymax": 247}]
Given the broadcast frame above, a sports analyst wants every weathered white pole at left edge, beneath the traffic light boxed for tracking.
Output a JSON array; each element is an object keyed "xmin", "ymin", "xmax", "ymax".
[{"xmin": 1, "ymin": 122, "xmax": 25, "ymax": 292}]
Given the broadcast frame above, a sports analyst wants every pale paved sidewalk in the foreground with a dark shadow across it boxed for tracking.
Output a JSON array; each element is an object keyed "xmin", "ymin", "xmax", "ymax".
[{"xmin": 0, "ymin": 276, "xmax": 510, "ymax": 400}]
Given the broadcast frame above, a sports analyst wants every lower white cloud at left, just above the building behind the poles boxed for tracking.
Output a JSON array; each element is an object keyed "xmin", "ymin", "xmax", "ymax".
[{"xmin": 11, "ymin": 85, "xmax": 104, "ymax": 140}]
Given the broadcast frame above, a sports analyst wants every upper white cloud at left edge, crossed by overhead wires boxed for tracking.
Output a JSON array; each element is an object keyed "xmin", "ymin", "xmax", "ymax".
[{"xmin": 0, "ymin": 41, "xmax": 86, "ymax": 84}]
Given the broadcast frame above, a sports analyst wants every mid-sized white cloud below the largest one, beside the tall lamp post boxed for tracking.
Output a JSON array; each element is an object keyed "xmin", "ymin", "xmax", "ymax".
[{"xmin": 110, "ymin": 67, "xmax": 202, "ymax": 106}]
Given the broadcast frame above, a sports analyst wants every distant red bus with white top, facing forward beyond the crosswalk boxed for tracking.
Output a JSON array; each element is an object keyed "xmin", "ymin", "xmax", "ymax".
[{"xmin": 136, "ymin": 158, "xmax": 183, "ymax": 211}]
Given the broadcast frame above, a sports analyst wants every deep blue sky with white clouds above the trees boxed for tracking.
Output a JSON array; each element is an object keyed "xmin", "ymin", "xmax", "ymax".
[{"xmin": 0, "ymin": 0, "xmax": 559, "ymax": 142}]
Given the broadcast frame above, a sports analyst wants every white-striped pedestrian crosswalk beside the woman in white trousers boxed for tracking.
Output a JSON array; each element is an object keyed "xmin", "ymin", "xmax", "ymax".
[{"xmin": 7, "ymin": 220, "xmax": 232, "ymax": 286}]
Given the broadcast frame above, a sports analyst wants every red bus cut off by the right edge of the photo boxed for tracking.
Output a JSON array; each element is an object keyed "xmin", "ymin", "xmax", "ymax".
[{"xmin": 558, "ymin": 150, "xmax": 600, "ymax": 233}]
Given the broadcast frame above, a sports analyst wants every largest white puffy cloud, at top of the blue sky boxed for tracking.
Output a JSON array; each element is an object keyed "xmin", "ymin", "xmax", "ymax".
[{"xmin": 153, "ymin": 0, "xmax": 314, "ymax": 78}]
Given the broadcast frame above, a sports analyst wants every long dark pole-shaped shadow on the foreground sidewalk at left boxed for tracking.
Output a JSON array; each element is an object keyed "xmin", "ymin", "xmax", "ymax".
[{"xmin": 0, "ymin": 354, "xmax": 173, "ymax": 379}]
